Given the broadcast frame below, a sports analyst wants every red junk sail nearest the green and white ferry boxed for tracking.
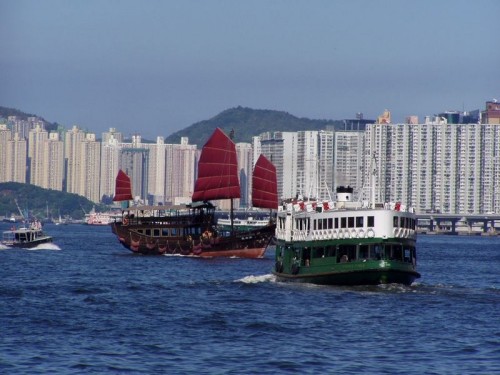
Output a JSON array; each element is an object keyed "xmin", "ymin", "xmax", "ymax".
[{"xmin": 252, "ymin": 154, "xmax": 278, "ymax": 209}]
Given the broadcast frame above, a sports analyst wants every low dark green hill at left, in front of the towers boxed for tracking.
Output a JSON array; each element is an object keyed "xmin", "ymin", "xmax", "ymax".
[{"xmin": 0, "ymin": 182, "xmax": 103, "ymax": 219}]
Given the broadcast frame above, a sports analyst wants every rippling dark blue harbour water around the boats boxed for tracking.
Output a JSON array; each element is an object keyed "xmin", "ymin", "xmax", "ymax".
[{"xmin": 0, "ymin": 225, "xmax": 500, "ymax": 374}]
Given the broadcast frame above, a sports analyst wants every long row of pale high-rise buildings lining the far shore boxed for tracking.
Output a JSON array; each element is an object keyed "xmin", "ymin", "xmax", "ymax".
[{"xmin": 0, "ymin": 101, "xmax": 500, "ymax": 214}]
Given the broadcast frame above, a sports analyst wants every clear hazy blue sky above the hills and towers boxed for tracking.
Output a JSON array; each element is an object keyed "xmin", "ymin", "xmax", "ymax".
[{"xmin": 0, "ymin": 0, "xmax": 500, "ymax": 139}]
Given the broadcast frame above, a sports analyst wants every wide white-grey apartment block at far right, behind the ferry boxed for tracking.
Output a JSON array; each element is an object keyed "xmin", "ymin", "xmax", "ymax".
[{"xmin": 365, "ymin": 118, "xmax": 500, "ymax": 214}]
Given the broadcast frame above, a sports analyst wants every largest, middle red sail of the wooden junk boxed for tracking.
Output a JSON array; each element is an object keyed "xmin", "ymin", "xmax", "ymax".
[{"xmin": 192, "ymin": 128, "xmax": 240, "ymax": 202}]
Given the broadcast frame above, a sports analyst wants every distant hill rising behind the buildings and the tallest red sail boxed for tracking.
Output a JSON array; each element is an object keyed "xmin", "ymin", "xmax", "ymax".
[{"xmin": 165, "ymin": 107, "xmax": 342, "ymax": 148}]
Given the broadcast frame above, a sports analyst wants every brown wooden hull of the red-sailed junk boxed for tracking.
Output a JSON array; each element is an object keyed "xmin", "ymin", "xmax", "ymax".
[{"xmin": 111, "ymin": 222, "xmax": 275, "ymax": 258}]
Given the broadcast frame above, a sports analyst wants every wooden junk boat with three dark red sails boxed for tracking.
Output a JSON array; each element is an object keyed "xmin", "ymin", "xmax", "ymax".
[{"xmin": 112, "ymin": 128, "xmax": 278, "ymax": 258}]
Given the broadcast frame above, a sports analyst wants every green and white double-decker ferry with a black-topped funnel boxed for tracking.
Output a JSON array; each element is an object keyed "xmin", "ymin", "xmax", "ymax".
[{"xmin": 273, "ymin": 187, "xmax": 420, "ymax": 285}]
